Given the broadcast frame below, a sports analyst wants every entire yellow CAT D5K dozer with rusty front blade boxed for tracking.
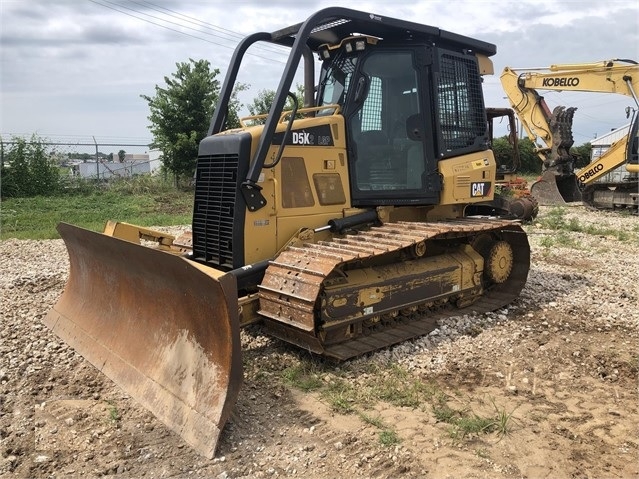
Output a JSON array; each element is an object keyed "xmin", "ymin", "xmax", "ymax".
[{"xmin": 46, "ymin": 8, "xmax": 530, "ymax": 457}]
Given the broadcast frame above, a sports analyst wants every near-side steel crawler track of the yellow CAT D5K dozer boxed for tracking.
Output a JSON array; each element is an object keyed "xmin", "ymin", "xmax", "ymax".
[{"xmin": 259, "ymin": 218, "xmax": 530, "ymax": 360}]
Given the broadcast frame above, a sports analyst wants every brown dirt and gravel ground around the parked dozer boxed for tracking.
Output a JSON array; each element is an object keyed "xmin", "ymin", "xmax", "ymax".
[{"xmin": 0, "ymin": 207, "xmax": 639, "ymax": 479}]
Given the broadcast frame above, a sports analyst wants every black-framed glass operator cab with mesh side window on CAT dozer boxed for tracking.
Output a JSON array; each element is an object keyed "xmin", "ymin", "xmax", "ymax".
[{"xmin": 317, "ymin": 35, "xmax": 488, "ymax": 206}]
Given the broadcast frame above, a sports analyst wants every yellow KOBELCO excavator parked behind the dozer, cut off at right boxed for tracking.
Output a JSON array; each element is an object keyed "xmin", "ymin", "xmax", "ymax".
[{"xmin": 501, "ymin": 59, "xmax": 639, "ymax": 208}]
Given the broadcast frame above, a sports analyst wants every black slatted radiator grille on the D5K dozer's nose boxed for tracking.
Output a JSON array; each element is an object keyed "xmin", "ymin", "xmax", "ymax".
[{"xmin": 193, "ymin": 154, "xmax": 239, "ymax": 270}]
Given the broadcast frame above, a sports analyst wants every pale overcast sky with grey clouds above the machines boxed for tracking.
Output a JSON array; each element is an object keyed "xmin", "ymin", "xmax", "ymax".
[{"xmin": 0, "ymin": 0, "xmax": 639, "ymax": 153}]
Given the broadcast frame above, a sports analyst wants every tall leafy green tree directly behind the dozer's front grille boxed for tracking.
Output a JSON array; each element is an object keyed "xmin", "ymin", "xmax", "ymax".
[{"xmin": 140, "ymin": 59, "xmax": 245, "ymax": 185}]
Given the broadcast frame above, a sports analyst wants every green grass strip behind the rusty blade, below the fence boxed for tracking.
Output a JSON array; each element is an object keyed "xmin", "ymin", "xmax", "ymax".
[{"xmin": 0, "ymin": 180, "xmax": 193, "ymax": 240}]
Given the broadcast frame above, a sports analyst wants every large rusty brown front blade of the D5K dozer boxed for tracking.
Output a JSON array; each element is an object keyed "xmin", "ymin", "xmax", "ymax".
[{"xmin": 44, "ymin": 223, "xmax": 242, "ymax": 458}]
